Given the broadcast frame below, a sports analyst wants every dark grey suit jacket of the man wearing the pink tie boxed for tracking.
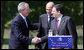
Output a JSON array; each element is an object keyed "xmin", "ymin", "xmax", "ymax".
[{"xmin": 50, "ymin": 15, "xmax": 77, "ymax": 49}]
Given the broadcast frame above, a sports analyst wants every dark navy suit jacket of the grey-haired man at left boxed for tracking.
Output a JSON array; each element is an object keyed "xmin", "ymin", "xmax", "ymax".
[{"xmin": 9, "ymin": 14, "xmax": 37, "ymax": 49}]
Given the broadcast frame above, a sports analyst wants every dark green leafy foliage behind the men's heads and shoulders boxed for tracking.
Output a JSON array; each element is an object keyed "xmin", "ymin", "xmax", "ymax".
[{"xmin": 4, "ymin": 1, "xmax": 83, "ymax": 28}]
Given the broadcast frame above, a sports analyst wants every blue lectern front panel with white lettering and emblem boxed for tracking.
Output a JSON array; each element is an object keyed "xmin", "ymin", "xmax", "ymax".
[{"xmin": 48, "ymin": 36, "xmax": 72, "ymax": 48}]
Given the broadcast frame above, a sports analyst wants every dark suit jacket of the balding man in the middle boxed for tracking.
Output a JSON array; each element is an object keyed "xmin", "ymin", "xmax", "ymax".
[{"xmin": 37, "ymin": 14, "xmax": 53, "ymax": 49}]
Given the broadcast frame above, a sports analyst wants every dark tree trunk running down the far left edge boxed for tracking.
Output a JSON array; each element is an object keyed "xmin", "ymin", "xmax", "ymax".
[{"xmin": 1, "ymin": 1, "xmax": 5, "ymax": 48}]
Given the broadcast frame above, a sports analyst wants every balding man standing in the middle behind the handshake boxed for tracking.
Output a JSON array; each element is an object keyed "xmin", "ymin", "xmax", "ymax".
[{"xmin": 36, "ymin": 2, "xmax": 54, "ymax": 49}]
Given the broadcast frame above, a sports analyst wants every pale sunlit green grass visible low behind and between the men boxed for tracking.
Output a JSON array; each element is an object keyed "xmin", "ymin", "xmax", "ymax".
[{"xmin": 2, "ymin": 29, "xmax": 83, "ymax": 49}]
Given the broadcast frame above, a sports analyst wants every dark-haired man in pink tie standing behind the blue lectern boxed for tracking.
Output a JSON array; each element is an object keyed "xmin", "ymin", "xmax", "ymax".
[{"xmin": 50, "ymin": 4, "xmax": 77, "ymax": 49}]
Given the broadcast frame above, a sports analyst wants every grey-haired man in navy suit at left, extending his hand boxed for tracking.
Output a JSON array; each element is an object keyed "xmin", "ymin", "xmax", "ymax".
[{"xmin": 9, "ymin": 2, "xmax": 38, "ymax": 49}]
